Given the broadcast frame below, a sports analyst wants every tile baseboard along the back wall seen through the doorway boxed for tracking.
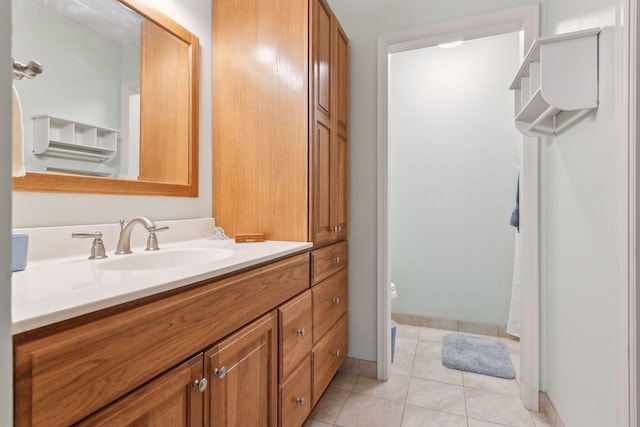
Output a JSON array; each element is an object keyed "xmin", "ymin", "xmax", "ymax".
[{"xmin": 391, "ymin": 313, "xmax": 518, "ymax": 340}]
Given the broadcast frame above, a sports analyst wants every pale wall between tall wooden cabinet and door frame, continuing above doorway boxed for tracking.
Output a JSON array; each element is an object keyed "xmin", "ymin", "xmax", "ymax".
[{"xmin": 329, "ymin": 0, "xmax": 531, "ymax": 360}]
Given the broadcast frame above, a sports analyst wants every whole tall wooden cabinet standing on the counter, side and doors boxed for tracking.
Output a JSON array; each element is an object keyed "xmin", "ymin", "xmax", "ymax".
[{"xmin": 213, "ymin": 0, "xmax": 349, "ymax": 245}]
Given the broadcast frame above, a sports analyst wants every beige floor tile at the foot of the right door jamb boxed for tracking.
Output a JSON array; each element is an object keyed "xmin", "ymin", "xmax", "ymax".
[{"xmin": 464, "ymin": 388, "xmax": 535, "ymax": 427}]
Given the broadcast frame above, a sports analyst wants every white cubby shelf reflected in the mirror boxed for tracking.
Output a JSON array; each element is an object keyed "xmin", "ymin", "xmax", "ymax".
[{"xmin": 32, "ymin": 115, "xmax": 119, "ymax": 161}]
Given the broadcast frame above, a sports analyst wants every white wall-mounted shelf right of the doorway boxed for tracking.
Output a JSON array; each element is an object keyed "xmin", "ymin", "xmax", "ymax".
[{"xmin": 510, "ymin": 28, "xmax": 600, "ymax": 137}]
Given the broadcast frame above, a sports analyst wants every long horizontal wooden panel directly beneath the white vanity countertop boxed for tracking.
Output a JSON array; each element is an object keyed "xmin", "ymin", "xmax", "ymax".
[{"xmin": 14, "ymin": 254, "xmax": 309, "ymax": 426}]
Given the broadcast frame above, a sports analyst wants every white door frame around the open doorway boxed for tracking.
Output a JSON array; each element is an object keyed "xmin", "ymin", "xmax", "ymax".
[{"xmin": 377, "ymin": 4, "xmax": 539, "ymax": 411}]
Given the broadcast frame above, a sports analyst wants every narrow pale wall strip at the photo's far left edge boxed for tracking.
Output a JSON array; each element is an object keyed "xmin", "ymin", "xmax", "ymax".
[{"xmin": 0, "ymin": 1, "xmax": 13, "ymax": 427}]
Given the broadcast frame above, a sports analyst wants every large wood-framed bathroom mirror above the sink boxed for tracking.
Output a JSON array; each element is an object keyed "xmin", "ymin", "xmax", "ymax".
[{"xmin": 12, "ymin": 0, "xmax": 199, "ymax": 197}]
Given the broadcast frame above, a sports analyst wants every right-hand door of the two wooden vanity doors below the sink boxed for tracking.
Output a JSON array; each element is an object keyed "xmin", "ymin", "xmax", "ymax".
[{"xmin": 205, "ymin": 311, "xmax": 277, "ymax": 427}]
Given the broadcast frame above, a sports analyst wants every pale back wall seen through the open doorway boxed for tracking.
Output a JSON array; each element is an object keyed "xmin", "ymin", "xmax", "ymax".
[{"xmin": 389, "ymin": 33, "xmax": 522, "ymax": 326}]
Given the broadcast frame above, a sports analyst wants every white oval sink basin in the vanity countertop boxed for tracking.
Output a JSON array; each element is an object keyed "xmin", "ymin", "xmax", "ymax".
[{"xmin": 96, "ymin": 248, "xmax": 233, "ymax": 270}]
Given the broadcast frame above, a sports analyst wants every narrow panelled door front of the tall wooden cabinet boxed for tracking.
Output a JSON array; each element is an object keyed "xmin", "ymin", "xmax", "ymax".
[{"xmin": 309, "ymin": 0, "xmax": 349, "ymax": 244}]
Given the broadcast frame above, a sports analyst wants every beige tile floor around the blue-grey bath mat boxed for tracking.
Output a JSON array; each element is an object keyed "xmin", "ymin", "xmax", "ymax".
[{"xmin": 304, "ymin": 324, "xmax": 549, "ymax": 427}]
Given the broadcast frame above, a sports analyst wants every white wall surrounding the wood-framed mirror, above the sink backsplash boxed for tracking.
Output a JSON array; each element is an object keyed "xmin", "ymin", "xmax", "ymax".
[{"xmin": 13, "ymin": 0, "xmax": 213, "ymax": 228}]
